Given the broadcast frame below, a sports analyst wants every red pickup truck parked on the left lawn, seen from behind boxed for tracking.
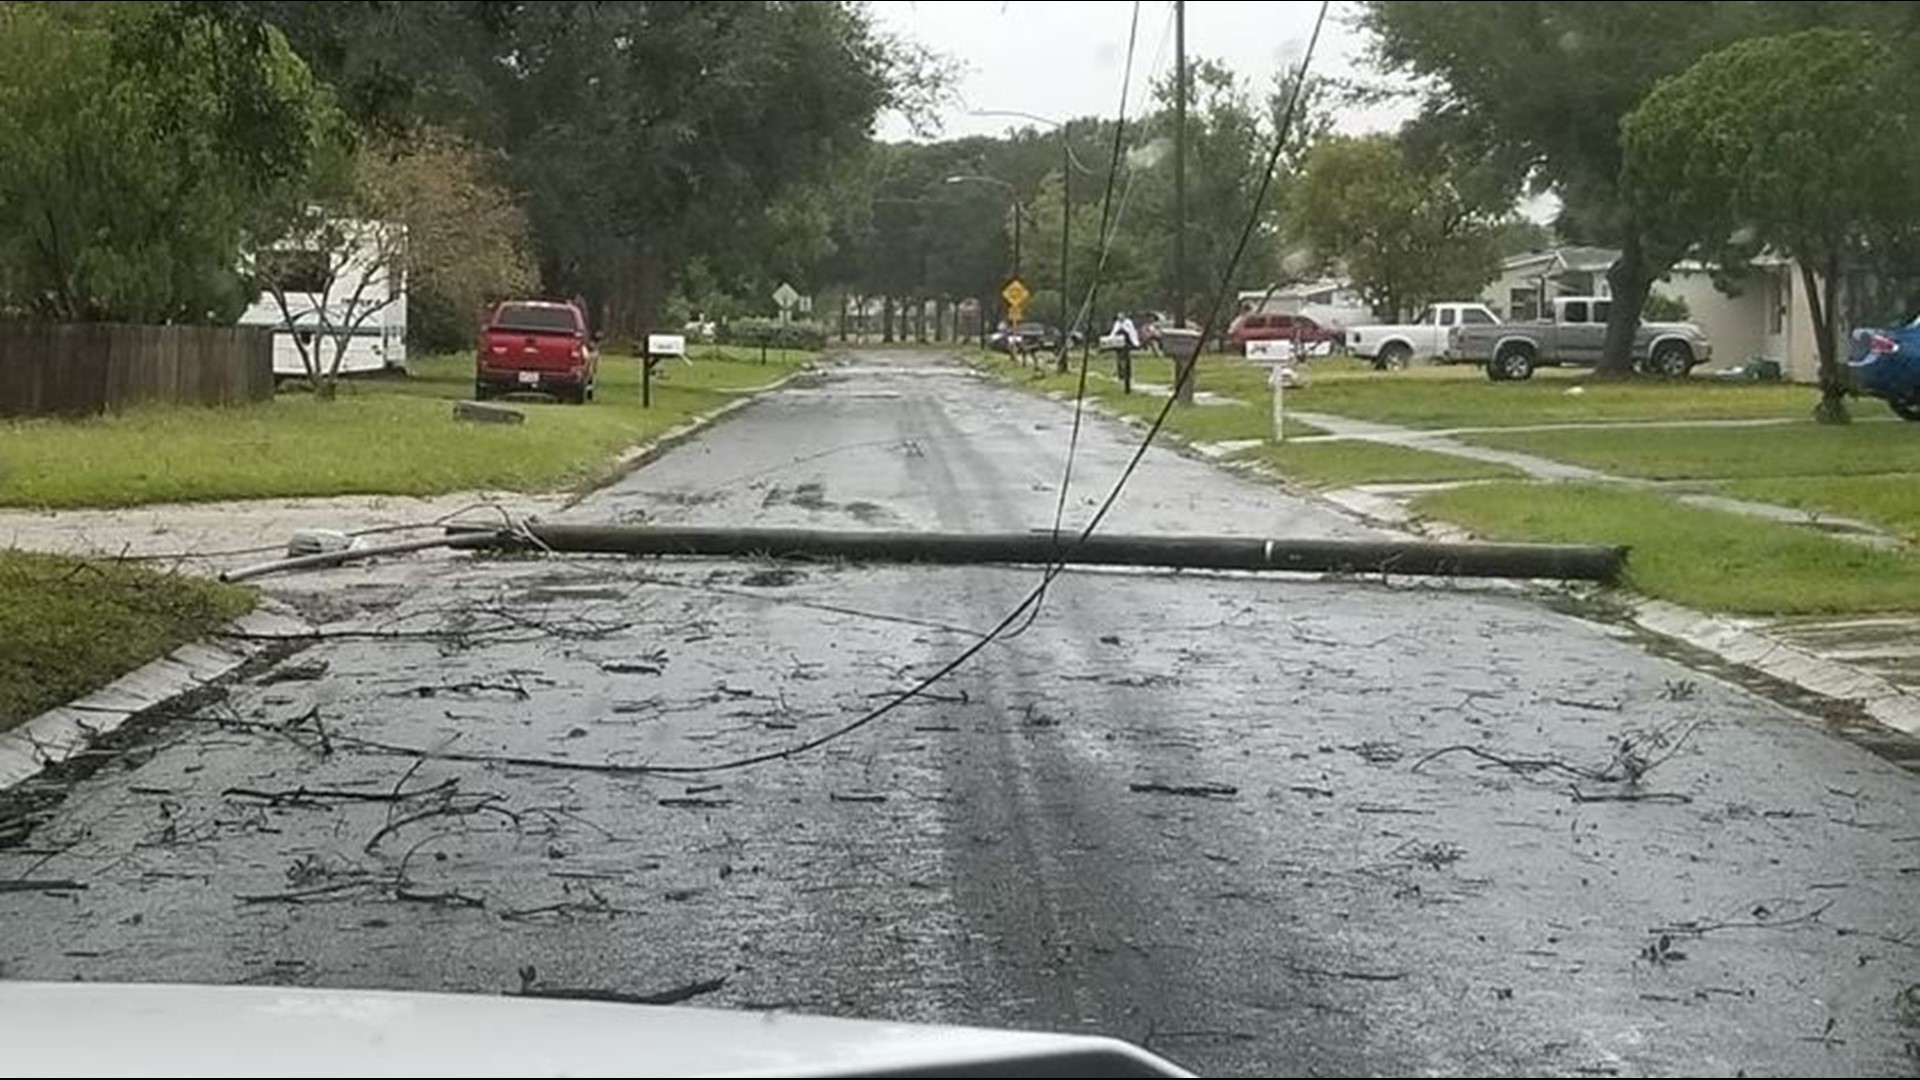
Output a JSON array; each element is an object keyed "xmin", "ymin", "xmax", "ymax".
[{"xmin": 474, "ymin": 300, "xmax": 599, "ymax": 405}]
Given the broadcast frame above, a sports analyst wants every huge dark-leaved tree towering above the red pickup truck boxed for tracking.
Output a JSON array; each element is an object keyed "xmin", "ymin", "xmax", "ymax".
[{"xmin": 252, "ymin": 0, "xmax": 939, "ymax": 332}]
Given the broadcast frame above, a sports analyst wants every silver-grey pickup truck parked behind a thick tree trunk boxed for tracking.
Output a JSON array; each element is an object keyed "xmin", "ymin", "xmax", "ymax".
[{"xmin": 1440, "ymin": 296, "xmax": 1713, "ymax": 380}]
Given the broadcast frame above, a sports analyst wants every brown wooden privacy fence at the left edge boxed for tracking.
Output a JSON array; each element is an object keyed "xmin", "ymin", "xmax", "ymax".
[{"xmin": 0, "ymin": 323, "xmax": 273, "ymax": 417}]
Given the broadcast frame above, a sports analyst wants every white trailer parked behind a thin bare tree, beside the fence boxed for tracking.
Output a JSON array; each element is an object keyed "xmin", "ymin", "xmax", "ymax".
[{"xmin": 240, "ymin": 221, "xmax": 407, "ymax": 379}]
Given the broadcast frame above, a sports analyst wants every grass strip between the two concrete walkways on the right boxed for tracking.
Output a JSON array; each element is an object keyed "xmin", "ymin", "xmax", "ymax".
[{"xmin": 1461, "ymin": 421, "xmax": 1920, "ymax": 480}]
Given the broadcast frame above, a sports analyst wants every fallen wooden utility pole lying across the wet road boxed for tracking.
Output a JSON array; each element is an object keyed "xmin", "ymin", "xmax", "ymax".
[{"xmin": 472, "ymin": 523, "xmax": 1626, "ymax": 580}]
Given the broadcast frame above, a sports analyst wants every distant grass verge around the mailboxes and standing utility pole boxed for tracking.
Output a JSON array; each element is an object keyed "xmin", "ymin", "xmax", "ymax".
[{"xmin": 972, "ymin": 352, "xmax": 1321, "ymax": 442}]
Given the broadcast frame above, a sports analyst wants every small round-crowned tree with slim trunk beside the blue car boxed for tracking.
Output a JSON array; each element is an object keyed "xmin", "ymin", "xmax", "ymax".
[{"xmin": 1622, "ymin": 29, "xmax": 1920, "ymax": 423}]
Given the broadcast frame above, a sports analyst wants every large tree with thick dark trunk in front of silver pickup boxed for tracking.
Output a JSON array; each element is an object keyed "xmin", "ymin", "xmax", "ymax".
[{"xmin": 1361, "ymin": 0, "xmax": 1755, "ymax": 375}]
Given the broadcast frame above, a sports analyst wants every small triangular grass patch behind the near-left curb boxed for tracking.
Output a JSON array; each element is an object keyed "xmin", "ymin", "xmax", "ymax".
[{"xmin": 0, "ymin": 552, "xmax": 253, "ymax": 730}]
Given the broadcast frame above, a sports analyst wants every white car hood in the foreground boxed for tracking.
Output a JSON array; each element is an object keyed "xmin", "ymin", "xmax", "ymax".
[{"xmin": 0, "ymin": 982, "xmax": 1190, "ymax": 1076}]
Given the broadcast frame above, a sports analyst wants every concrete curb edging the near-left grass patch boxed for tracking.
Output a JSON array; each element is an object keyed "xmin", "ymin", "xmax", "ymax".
[{"xmin": 0, "ymin": 600, "xmax": 309, "ymax": 792}]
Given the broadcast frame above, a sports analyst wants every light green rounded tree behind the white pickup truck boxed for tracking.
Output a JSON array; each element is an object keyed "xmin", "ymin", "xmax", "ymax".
[{"xmin": 1290, "ymin": 135, "xmax": 1496, "ymax": 319}]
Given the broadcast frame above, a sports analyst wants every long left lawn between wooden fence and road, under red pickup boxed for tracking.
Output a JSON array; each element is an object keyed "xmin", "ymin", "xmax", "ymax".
[{"xmin": 0, "ymin": 346, "xmax": 812, "ymax": 507}]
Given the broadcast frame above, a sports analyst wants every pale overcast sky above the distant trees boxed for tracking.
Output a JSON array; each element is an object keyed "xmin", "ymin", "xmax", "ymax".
[{"xmin": 874, "ymin": 0, "xmax": 1411, "ymax": 140}]
